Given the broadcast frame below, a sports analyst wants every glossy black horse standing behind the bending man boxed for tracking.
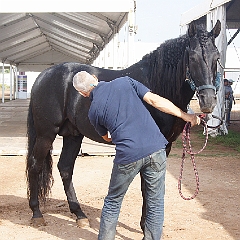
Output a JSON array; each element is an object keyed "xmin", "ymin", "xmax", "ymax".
[{"xmin": 26, "ymin": 21, "xmax": 221, "ymax": 227}]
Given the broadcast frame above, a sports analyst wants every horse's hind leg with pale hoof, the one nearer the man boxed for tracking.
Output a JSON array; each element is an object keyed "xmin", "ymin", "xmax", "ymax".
[{"xmin": 58, "ymin": 136, "xmax": 89, "ymax": 227}]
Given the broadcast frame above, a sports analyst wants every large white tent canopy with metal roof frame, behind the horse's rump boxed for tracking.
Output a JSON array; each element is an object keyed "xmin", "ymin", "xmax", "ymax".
[{"xmin": 0, "ymin": 0, "xmax": 134, "ymax": 72}]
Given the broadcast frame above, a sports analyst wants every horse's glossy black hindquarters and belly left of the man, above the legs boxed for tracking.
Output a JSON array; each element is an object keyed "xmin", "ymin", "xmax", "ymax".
[{"xmin": 30, "ymin": 63, "xmax": 118, "ymax": 141}]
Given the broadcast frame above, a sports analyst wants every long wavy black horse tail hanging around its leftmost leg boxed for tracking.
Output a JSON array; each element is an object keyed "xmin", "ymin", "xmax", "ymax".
[{"xmin": 26, "ymin": 100, "xmax": 54, "ymax": 202}]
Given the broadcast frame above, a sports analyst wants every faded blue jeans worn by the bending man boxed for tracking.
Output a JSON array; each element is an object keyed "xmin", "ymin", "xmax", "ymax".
[{"xmin": 98, "ymin": 149, "xmax": 166, "ymax": 240}]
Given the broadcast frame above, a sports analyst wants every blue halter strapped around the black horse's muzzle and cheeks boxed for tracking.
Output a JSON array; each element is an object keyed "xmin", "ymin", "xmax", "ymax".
[{"xmin": 185, "ymin": 66, "xmax": 221, "ymax": 93}]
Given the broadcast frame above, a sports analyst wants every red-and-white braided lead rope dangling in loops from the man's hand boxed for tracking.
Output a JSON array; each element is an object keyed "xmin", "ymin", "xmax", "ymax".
[{"xmin": 178, "ymin": 115, "xmax": 208, "ymax": 200}]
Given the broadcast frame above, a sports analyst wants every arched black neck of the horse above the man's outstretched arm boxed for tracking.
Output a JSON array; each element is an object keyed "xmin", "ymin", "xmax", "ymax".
[{"xmin": 117, "ymin": 36, "xmax": 188, "ymax": 103}]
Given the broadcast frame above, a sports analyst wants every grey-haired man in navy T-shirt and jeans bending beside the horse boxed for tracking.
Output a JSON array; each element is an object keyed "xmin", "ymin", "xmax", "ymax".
[{"xmin": 73, "ymin": 71, "xmax": 200, "ymax": 240}]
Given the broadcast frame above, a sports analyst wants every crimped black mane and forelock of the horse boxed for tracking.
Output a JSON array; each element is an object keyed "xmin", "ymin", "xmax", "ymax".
[{"xmin": 141, "ymin": 25, "xmax": 209, "ymax": 105}]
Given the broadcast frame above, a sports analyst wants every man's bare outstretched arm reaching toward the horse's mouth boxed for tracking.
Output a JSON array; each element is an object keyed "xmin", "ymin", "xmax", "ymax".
[{"xmin": 143, "ymin": 92, "xmax": 201, "ymax": 126}]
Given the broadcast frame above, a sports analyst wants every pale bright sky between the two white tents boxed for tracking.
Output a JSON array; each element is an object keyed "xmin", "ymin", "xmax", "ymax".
[{"xmin": 135, "ymin": 0, "xmax": 204, "ymax": 43}]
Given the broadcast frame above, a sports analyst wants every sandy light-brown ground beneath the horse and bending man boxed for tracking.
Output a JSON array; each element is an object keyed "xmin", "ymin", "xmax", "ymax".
[{"xmin": 0, "ymin": 100, "xmax": 240, "ymax": 240}]
